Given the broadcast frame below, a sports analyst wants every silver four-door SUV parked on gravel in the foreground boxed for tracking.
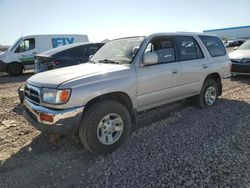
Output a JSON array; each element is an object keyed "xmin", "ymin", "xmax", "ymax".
[{"xmin": 23, "ymin": 33, "xmax": 230, "ymax": 154}]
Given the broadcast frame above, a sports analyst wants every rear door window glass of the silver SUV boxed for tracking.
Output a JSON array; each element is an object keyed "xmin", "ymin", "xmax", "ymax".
[{"xmin": 175, "ymin": 36, "xmax": 204, "ymax": 61}]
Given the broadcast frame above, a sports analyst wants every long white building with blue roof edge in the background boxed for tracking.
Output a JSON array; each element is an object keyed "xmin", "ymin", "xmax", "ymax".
[{"xmin": 203, "ymin": 25, "xmax": 250, "ymax": 39}]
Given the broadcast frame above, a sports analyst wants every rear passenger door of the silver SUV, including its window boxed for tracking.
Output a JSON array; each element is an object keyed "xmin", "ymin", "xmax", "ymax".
[{"xmin": 174, "ymin": 36, "xmax": 209, "ymax": 96}]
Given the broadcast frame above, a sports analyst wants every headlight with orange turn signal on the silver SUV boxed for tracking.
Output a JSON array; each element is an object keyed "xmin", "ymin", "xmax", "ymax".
[{"xmin": 41, "ymin": 88, "xmax": 71, "ymax": 104}]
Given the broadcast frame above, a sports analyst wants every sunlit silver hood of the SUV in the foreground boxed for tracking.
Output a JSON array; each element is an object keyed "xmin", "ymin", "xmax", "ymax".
[{"xmin": 27, "ymin": 63, "xmax": 129, "ymax": 88}]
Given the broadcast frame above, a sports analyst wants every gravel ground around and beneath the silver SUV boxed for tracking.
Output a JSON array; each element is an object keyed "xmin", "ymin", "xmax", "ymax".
[{"xmin": 0, "ymin": 74, "xmax": 250, "ymax": 188}]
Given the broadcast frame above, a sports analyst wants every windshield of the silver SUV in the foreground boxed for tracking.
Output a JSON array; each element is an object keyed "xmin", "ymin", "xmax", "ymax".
[{"xmin": 90, "ymin": 37, "xmax": 145, "ymax": 64}]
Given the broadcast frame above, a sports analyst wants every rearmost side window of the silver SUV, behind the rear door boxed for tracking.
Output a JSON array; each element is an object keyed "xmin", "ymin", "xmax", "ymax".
[{"xmin": 199, "ymin": 36, "xmax": 227, "ymax": 57}]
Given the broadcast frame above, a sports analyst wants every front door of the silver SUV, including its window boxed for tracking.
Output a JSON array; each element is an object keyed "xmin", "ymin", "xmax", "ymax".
[{"xmin": 137, "ymin": 36, "xmax": 181, "ymax": 111}]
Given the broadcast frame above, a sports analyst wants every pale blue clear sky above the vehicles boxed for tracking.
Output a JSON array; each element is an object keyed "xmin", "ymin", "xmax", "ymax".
[{"xmin": 0, "ymin": 0, "xmax": 250, "ymax": 45}]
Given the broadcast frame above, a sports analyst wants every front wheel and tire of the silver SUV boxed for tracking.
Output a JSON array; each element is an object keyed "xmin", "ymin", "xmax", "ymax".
[{"xmin": 79, "ymin": 100, "xmax": 131, "ymax": 155}]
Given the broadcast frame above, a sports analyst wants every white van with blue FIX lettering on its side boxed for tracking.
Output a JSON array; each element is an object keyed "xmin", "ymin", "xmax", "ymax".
[{"xmin": 0, "ymin": 34, "xmax": 89, "ymax": 76}]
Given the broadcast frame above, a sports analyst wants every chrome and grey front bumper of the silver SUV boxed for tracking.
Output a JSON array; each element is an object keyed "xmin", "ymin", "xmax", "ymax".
[{"xmin": 23, "ymin": 98, "xmax": 84, "ymax": 135}]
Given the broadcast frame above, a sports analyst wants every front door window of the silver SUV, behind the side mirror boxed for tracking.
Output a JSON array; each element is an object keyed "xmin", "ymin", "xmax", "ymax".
[{"xmin": 144, "ymin": 37, "xmax": 176, "ymax": 64}]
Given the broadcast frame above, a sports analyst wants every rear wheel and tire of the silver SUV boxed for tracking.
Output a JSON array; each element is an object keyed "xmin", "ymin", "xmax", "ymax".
[{"xmin": 193, "ymin": 79, "xmax": 219, "ymax": 108}]
